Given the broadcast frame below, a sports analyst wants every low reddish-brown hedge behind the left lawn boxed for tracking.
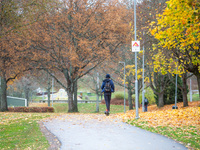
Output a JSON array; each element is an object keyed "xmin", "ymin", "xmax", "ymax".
[{"xmin": 8, "ymin": 107, "xmax": 54, "ymax": 113}]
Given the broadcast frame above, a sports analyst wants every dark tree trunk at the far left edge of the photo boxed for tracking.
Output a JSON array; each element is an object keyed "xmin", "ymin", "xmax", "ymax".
[{"xmin": 1, "ymin": 77, "xmax": 8, "ymax": 111}]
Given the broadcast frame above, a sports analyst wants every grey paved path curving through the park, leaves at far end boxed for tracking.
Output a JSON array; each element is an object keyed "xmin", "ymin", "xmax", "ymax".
[{"xmin": 44, "ymin": 114, "xmax": 187, "ymax": 150}]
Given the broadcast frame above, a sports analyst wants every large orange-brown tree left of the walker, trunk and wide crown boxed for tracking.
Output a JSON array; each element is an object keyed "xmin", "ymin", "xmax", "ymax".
[{"xmin": 28, "ymin": 0, "xmax": 129, "ymax": 112}]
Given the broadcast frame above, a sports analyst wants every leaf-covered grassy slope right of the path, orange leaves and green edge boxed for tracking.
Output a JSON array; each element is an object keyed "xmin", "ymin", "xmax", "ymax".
[{"xmin": 120, "ymin": 101, "xmax": 200, "ymax": 150}]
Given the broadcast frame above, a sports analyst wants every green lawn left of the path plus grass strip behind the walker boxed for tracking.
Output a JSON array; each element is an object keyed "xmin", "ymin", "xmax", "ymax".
[{"xmin": 0, "ymin": 103, "xmax": 127, "ymax": 150}]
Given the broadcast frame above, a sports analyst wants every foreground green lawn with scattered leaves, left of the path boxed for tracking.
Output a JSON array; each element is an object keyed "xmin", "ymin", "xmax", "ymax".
[{"xmin": 0, "ymin": 112, "xmax": 54, "ymax": 150}]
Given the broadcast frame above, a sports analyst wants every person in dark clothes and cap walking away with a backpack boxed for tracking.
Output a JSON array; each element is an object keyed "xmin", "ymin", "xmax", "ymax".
[{"xmin": 101, "ymin": 74, "xmax": 115, "ymax": 114}]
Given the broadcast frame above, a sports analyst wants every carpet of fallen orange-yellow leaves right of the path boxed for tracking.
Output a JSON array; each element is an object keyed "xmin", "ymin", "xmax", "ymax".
[{"xmin": 120, "ymin": 101, "xmax": 200, "ymax": 127}]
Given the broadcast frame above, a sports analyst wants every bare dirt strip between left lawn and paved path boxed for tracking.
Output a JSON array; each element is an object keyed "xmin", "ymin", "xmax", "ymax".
[{"xmin": 38, "ymin": 121, "xmax": 61, "ymax": 150}]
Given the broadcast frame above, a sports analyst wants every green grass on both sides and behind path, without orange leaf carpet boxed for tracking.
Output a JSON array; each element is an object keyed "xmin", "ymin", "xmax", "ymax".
[{"xmin": 0, "ymin": 103, "xmax": 200, "ymax": 150}]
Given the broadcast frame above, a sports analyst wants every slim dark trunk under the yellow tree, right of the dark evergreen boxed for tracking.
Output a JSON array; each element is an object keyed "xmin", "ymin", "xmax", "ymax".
[{"xmin": 181, "ymin": 73, "xmax": 188, "ymax": 107}]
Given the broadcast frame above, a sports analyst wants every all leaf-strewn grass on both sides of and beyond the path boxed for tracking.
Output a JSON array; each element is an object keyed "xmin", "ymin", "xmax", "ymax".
[{"xmin": 0, "ymin": 101, "xmax": 200, "ymax": 150}]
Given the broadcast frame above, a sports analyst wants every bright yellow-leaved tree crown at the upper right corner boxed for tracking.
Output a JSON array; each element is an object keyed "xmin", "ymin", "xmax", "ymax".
[{"xmin": 151, "ymin": 0, "xmax": 200, "ymax": 95}]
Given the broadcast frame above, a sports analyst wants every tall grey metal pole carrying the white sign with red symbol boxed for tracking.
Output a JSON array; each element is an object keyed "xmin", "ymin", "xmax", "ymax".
[{"xmin": 134, "ymin": 0, "xmax": 139, "ymax": 119}]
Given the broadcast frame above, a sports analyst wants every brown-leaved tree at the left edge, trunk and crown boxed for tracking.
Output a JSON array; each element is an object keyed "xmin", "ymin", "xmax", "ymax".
[{"xmin": 0, "ymin": 0, "xmax": 54, "ymax": 111}]
